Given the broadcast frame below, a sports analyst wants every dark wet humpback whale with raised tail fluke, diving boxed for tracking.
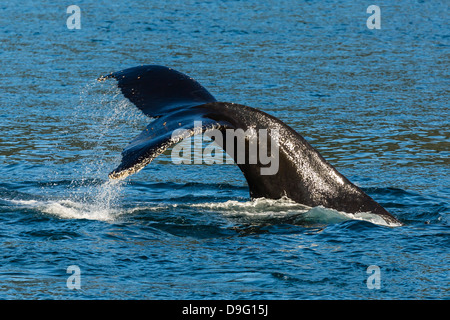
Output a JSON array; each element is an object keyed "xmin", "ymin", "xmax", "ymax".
[{"xmin": 98, "ymin": 65, "xmax": 401, "ymax": 225}]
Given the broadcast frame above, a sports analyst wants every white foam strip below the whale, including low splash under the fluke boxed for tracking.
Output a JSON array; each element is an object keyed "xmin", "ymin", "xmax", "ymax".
[{"xmin": 8, "ymin": 194, "xmax": 399, "ymax": 227}]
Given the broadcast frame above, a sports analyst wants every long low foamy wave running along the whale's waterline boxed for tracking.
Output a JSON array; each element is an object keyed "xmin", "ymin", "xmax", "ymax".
[{"xmin": 4, "ymin": 194, "xmax": 400, "ymax": 227}]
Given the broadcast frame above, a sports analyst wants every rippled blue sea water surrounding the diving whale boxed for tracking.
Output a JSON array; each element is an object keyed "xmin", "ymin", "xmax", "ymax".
[{"xmin": 0, "ymin": 0, "xmax": 450, "ymax": 299}]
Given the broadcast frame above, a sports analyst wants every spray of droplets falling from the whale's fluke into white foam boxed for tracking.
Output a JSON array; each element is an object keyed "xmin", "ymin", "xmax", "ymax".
[{"xmin": 36, "ymin": 81, "xmax": 148, "ymax": 221}]
